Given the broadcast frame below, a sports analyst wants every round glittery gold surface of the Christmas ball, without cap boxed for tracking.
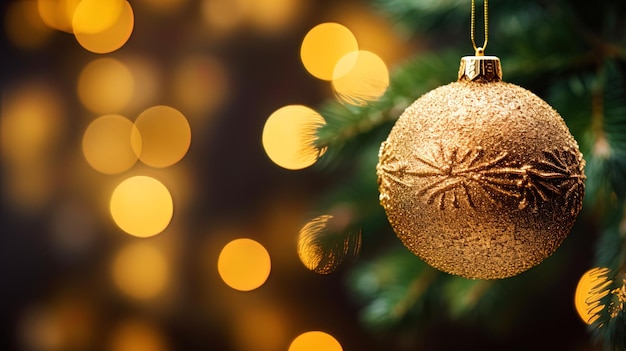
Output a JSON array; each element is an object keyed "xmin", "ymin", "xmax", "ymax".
[{"xmin": 377, "ymin": 81, "xmax": 585, "ymax": 279}]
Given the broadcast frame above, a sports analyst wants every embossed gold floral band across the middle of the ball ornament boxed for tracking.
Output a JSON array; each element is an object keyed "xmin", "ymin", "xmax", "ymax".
[{"xmin": 381, "ymin": 142, "xmax": 584, "ymax": 213}]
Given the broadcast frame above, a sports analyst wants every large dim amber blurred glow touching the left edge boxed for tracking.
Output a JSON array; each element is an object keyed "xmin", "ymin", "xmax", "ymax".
[{"xmin": 0, "ymin": 81, "xmax": 67, "ymax": 212}]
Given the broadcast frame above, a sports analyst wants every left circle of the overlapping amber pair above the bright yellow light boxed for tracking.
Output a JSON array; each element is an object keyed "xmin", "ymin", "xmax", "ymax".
[{"xmin": 82, "ymin": 115, "xmax": 141, "ymax": 174}]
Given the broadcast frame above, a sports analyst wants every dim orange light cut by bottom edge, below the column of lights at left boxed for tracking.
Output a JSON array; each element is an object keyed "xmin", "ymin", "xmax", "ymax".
[{"xmin": 107, "ymin": 319, "xmax": 169, "ymax": 351}]
